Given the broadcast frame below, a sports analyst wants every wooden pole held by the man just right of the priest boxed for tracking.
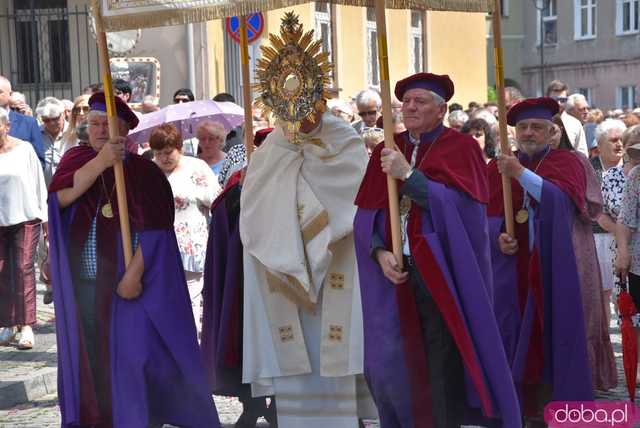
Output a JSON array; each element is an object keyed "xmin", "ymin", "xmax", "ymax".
[{"xmin": 375, "ymin": 0, "xmax": 403, "ymax": 269}]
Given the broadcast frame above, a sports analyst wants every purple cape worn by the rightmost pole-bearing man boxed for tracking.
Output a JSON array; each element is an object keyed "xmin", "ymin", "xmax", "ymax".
[{"xmin": 489, "ymin": 180, "xmax": 593, "ymax": 401}]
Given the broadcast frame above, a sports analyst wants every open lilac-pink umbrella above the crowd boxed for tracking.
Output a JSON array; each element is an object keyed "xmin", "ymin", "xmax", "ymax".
[{"xmin": 128, "ymin": 100, "xmax": 244, "ymax": 143}]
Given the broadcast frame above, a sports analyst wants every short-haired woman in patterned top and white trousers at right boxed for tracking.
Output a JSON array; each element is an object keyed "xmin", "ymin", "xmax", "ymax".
[{"xmin": 591, "ymin": 119, "xmax": 626, "ymax": 320}]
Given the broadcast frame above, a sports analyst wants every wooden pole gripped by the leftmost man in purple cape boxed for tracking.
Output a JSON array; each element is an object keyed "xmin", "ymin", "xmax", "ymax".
[{"xmin": 93, "ymin": 0, "xmax": 133, "ymax": 267}]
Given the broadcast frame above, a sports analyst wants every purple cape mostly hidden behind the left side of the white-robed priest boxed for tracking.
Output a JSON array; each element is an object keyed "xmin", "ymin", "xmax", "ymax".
[{"xmin": 202, "ymin": 184, "xmax": 243, "ymax": 396}]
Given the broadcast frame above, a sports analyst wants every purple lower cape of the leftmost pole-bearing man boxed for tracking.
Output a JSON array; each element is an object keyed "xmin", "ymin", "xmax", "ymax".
[{"xmin": 49, "ymin": 193, "xmax": 220, "ymax": 427}]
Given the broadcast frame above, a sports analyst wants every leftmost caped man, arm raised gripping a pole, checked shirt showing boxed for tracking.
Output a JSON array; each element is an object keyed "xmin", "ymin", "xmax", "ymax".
[{"xmin": 49, "ymin": 93, "xmax": 218, "ymax": 427}]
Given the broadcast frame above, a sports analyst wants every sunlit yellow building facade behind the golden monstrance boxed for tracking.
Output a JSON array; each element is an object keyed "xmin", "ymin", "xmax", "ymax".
[{"xmin": 207, "ymin": 2, "xmax": 487, "ymax": 105}]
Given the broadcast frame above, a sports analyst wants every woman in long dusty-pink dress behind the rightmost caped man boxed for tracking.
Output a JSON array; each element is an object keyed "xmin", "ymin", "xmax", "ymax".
[{"xmin": 551, "ymin": 115, "xmax": 618, "ymax": 391}]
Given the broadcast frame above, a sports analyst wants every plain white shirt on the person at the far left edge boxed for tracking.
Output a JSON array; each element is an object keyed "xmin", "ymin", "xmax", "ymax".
[{"xmin": 0, "ymin": 140, "xmax": 47, "ymax": 227}]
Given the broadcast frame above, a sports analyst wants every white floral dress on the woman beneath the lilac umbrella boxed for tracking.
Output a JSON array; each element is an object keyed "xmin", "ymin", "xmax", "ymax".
[{"xmin": 167, "ymin": 156, "xmax": 220, "ymax": 272}]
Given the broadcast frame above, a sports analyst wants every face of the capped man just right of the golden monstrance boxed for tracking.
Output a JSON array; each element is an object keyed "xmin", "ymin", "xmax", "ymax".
[{"xmin": 402, "ymin": 88, "xmax": 447, "ymax": 136}]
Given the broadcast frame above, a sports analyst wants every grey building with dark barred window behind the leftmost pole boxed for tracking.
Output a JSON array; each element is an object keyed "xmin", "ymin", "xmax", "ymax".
[{"xmin": 0, "ymin": 0, "xmax": 209, "ymax": 106}]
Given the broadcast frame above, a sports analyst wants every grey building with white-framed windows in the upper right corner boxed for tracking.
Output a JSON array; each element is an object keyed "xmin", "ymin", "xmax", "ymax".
[{"xmin": 512, "ymin": 0, "xmax": 640, "ymax": 109}]
